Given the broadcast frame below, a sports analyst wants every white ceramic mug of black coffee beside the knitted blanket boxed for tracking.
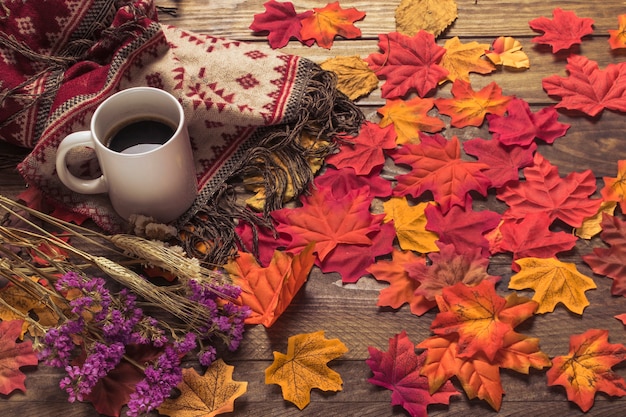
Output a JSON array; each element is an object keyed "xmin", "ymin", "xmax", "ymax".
[{"xmin": 56, "ymin": 87, "xmax": 197, "ymax": 223}]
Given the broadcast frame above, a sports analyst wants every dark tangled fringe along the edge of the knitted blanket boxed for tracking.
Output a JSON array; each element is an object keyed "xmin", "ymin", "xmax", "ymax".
[{"xmin": 177, "ymin": 66, "xmax": 365, "ymax": 266}]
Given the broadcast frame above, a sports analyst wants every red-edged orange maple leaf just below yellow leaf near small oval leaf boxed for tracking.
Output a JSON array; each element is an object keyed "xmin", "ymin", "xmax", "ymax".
[{"xmin": 435, "ymin": 78, "xmax": 513, "ymax": 128}]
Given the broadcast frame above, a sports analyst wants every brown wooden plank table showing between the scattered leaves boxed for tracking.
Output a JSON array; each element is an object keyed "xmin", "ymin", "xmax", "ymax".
[{"xmin": 0, "ymin": 0, "xmax": 626, "ymax": 417}]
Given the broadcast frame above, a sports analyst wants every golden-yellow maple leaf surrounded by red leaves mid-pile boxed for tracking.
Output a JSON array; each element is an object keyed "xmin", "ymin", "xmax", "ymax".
[{"xmin": 383, "ymin": 197, "xmax": 439, "ymax": 253}]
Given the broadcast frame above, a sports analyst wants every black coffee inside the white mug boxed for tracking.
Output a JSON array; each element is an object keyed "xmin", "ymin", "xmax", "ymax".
[{"xmin": 104, "ymin": 119, "xmax": 175, "ymax": 152}]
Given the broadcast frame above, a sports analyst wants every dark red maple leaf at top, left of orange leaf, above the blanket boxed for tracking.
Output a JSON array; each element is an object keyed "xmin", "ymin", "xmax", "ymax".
[{"xmin": 250, "ymin": 0, "xmax": 315, "ymax": 49}]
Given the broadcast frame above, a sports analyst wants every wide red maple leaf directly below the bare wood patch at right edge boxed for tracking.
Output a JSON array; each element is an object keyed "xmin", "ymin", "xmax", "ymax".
[{"xmin": 497, "ymin": 152, "xmax": 602, "ymax": 227}]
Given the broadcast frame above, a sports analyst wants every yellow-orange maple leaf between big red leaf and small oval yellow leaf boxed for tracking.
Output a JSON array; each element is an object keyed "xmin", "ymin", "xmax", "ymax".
[{"xmin": 439, "ymin": 36, "xmax": 496, "ymax": 84}]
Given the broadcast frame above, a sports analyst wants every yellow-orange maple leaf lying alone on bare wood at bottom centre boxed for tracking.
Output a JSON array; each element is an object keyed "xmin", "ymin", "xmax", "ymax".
[{"xmin": 265, "ymin": 330, "xmax": 348, "ymax": 410}]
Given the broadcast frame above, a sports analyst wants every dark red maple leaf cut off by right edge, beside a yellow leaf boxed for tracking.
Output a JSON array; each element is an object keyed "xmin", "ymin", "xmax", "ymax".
[{"xmin": 582, "ymin": 214, "xmax": 626, "ymax": 297}]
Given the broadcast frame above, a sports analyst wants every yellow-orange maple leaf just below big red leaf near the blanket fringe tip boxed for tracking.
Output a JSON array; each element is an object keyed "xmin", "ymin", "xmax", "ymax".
[{"xmin": 378, "ymin": 97, "xmax": 445, "ymax": 145}]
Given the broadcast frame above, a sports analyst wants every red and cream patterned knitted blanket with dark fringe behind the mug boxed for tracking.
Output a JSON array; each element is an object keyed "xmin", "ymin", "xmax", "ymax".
[{"xmin": 0, "ymin": 0, "xmax": 363, "ymax": 262}]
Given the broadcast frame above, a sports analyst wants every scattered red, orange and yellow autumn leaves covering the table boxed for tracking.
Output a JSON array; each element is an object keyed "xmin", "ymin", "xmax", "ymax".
[{"xmin": 0, "ymin": 0, "xmax": 626, "ymax": 417}]
